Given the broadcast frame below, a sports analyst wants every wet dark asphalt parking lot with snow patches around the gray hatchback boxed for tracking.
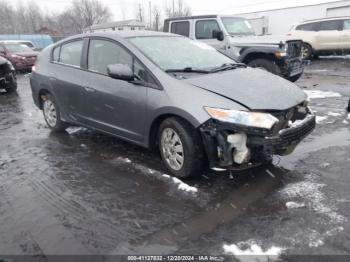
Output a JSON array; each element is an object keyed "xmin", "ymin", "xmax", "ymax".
[{"xmin": 0, "ymin": 57, "xmax": 350, "ymax": 261}]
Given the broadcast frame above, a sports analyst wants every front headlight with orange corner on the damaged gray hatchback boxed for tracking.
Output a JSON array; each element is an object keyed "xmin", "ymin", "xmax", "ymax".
[{"xmin": 204, "ymin": 107, "xmax": 278, "ymax": 129}]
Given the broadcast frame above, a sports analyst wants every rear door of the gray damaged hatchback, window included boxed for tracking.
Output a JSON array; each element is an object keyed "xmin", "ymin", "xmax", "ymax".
[{"xmin": 49, "ymin": 39, "xmax": 84, "ymax": 122}]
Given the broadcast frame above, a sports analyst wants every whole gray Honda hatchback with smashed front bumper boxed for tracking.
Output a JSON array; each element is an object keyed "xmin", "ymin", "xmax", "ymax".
[{"xmin": 30, "ymin": 31, "xmax": 315, "ymax": 178}]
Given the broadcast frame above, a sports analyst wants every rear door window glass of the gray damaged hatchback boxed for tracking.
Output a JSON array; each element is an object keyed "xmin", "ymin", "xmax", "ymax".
[{"xmin": 59, "ymin": 40, "xmax": 84, "ymax": 67}]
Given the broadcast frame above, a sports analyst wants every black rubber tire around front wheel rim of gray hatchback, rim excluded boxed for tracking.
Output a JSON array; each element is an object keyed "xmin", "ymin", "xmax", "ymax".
[{"xmin": 158, "ymin": 117, "xmax": 205, "ymax": 178}]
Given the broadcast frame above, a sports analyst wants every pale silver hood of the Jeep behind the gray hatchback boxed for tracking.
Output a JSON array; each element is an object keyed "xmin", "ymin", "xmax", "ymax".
[{"xmin": 230, "ymin": 35, "xmax": 292, "ymax": 45}]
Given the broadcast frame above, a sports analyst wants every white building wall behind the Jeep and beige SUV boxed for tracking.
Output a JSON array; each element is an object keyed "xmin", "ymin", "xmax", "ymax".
[{"xmin": 236, "ymin": 0, "xmax": 350, "ymax": 34}]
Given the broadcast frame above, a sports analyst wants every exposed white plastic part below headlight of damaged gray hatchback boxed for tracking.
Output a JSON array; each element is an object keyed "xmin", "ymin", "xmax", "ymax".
[{"xmin": 227, "ymin": 133, "xmax": 250, "ymax": 164}]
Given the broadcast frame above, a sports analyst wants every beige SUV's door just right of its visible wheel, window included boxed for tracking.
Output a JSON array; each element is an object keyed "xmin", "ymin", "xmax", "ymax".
[{"xmin": 315, "ymin": 20, "xmax": 342, "ymax": 50}]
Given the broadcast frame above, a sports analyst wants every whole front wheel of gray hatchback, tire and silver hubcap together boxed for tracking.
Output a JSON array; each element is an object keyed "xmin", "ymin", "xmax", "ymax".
[{"xmin": 158, "ymin": 117, "xmax": 205, "ymax": 178}]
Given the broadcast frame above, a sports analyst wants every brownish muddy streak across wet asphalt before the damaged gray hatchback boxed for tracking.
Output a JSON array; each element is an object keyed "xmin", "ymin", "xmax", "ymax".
[{"xmin": 113, "ymin": 168, "xmax": 287, "ymax": 254}]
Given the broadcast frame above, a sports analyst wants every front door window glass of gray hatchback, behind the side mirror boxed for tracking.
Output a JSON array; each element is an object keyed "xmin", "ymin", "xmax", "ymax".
[{"xmin": 88, "ymin": 39, "xmax": 133, "ymax": 75}]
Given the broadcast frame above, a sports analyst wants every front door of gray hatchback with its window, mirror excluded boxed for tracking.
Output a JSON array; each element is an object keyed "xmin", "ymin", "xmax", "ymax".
[{"xmin": 80, "ymin": 38, "xmax": 151, "ymax": 142}]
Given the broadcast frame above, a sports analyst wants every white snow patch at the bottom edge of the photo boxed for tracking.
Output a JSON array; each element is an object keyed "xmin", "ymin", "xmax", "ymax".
[{"xmin": 223, "ymin": 240, "xmax": 284, "ymax": 262}]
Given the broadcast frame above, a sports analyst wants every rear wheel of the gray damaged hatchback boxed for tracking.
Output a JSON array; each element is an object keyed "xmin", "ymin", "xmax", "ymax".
[{"xmin": 43, "ymin": 94, "xmax": 68, "ymax": 132}]
